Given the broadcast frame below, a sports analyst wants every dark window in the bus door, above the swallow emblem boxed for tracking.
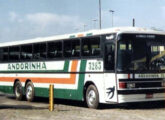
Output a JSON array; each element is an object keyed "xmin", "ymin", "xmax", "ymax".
[{"xmin": 104, "ymin": 43, "xmax": 115, "ymax": 70}]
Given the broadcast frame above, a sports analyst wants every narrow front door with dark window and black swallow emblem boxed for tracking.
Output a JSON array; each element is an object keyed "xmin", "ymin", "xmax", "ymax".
[{"xmin": 104, "ymin": 42, "xmax": 117, "ymax": 102}]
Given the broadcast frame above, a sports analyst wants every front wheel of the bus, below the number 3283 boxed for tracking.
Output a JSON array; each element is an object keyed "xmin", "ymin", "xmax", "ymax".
[{"xmin": 86, "ymin": 85, "xmax": 99, "ymax": 109}]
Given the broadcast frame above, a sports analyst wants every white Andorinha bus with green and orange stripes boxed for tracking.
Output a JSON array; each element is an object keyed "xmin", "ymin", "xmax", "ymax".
[{"xmin": 0, "ymin": 27, "xmax": 165, "ymax": 109}]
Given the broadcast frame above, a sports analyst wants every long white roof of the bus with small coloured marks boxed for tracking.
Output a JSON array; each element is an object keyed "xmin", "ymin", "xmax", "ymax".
[{"xmin": 0, "ymin": 27, "xmax": 165, "ymax": 47}]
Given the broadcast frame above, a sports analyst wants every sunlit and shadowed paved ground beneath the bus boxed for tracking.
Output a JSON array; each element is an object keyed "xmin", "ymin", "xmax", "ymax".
[{"xmin": 0, "ymin": 93, "xmax": 165, "ymax": 120}]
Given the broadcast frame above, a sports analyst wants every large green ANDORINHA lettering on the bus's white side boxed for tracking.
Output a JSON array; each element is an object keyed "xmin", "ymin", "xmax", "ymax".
[{"xmin": 8, "ymin": 62, "xmax": 47, "ymax": 70}]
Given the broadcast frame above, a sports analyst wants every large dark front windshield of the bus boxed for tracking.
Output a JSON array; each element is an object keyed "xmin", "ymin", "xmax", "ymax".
[{"xmin": 117, "ymin": 34, "xmax": 165, "ymax": 72}]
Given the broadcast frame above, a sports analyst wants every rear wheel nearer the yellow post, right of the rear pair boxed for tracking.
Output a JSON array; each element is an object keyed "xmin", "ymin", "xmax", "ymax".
[{"xmin": 25, "ymin": 82, "xmax": 34, "ymax": 102}]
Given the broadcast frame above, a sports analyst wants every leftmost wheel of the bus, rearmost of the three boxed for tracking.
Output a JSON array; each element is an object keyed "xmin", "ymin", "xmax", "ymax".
[{"xmin": 14, "ymin": 81, "xmax": 23, "ymax": 100}]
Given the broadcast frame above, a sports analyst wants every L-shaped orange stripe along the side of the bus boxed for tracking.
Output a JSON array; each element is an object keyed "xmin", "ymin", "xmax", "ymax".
[{"xmin": 0, "ymin": 60, "xmax": 78, "ymax": 84}]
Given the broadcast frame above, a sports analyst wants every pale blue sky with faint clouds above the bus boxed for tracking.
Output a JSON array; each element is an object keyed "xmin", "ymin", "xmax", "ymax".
[{"xmin": 0, "ymin": 0, "xmax": 165, "ymax": 42}]
